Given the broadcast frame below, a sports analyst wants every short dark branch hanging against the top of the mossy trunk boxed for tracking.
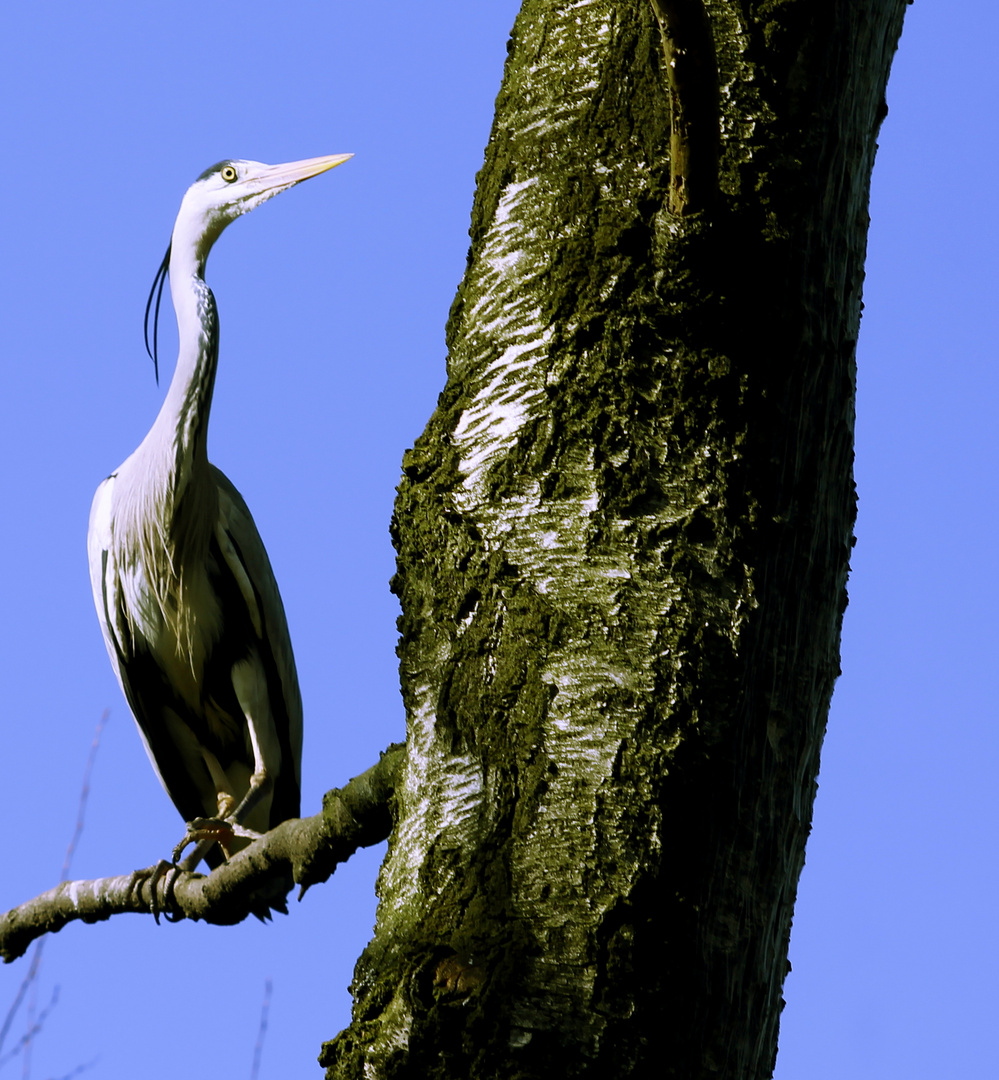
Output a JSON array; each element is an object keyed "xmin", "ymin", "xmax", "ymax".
[{"xmin": 651, "ymin": 0, "xmax": 721, "ymax": 214}]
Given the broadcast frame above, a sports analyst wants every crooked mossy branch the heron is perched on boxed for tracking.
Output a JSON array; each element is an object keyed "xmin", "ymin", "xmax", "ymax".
[{"xmin": 0, "ymin": 743, "xmax": 405, "ymax": 963}]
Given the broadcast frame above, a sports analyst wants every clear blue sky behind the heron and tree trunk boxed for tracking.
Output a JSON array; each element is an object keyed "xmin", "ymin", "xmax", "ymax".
[{"xmin": 0, "ymin": 0, "xmax": 999, "ymax": 1080}]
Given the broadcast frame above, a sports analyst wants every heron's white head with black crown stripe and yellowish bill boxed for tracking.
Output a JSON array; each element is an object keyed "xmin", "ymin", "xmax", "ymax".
[{"xmin": 174, "ymin": 153, "xmax": 353, "ymax": 264}]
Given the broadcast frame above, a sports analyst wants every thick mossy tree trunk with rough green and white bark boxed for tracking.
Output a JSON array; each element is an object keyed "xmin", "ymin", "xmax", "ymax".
[{"xmin": 321, "ymin": 0, "xmax": 904, "ymax": 1080}]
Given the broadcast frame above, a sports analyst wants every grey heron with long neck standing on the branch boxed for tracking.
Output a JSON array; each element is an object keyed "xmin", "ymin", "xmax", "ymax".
[{"xmin": 87, "ymin": 153, "xmax": 351, "ymax": 868}]
